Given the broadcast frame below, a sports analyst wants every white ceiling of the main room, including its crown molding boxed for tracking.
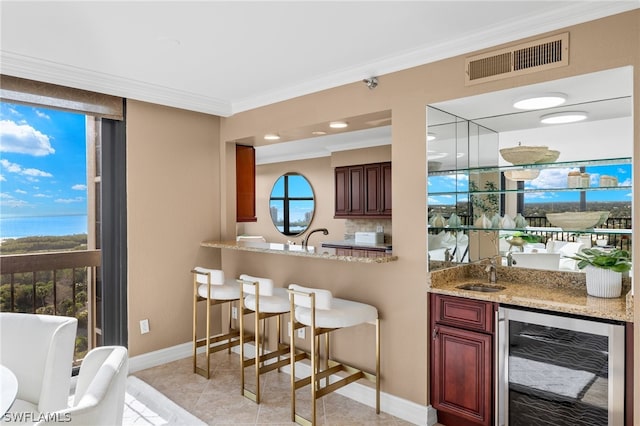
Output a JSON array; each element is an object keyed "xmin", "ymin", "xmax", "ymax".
[{"xmin": 0, "ymin": 0, "xmax": 640, "ymax": 116}]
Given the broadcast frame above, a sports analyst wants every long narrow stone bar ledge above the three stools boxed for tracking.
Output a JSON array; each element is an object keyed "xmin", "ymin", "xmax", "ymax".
[{"xmin": 200, "ymin": 241, "xmax": 398, "ymax": 263}]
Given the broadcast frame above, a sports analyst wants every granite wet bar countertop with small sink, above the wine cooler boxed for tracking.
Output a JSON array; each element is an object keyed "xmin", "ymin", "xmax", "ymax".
[{"xmin": 428, "ymin": 264, "xmax": 633, "ymax": 322}]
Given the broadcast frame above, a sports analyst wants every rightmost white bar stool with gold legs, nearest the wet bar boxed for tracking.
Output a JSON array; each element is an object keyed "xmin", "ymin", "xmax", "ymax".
[{"xmin": 288, "ymin": 284, "xmax": 380, "ymax": 426}]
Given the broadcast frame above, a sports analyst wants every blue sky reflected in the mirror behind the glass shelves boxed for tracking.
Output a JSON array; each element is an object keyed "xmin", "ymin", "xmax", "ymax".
[{"xmin": 428, "ymin": 164, "xmax": 632, "ymax": 205}]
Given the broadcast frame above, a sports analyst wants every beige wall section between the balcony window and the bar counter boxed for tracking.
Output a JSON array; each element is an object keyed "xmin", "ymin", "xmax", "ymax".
[{"xmin": 127, "ymin": 101, "xmax": 221, "ymax": 356}]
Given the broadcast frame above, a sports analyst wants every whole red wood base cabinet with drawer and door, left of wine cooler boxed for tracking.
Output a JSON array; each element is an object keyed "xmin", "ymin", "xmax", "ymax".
[{"xmin": 430, "ymin": 294, "xmax": 496, "ymax": 426}]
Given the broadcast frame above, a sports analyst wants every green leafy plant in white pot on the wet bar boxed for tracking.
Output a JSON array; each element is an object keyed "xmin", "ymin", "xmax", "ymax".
[{"xmin": 570, "ymin": 248, "xmax": 631, "ymax": 297}]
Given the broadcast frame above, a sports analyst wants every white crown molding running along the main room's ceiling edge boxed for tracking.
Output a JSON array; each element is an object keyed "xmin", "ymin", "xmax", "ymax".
[{"xmin": 0, "ymin": 0, "xmax": 640, "ymax": 117}]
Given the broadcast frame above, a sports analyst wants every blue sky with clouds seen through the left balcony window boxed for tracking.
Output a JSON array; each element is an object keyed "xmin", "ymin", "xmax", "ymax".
[{"xmin": 0, "ymin": 102, "xmax": 87, "ymax": 218}]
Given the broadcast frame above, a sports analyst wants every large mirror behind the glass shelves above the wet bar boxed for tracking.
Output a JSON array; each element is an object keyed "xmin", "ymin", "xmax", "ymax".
[{"xmin": 427, "ymin": 67, "xmax": 633, "ymax": 270}]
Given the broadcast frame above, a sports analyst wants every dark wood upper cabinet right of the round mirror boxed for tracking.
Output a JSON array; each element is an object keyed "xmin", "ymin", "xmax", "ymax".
[{"xmin": 334, "ymin": 162, "xmax": 391, "ymax": 218}]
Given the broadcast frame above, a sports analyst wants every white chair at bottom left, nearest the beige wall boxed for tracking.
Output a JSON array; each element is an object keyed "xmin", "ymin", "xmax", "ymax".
[{"xmin": 36, "ymin": 346, "xmax": 129, "ymax": 426}]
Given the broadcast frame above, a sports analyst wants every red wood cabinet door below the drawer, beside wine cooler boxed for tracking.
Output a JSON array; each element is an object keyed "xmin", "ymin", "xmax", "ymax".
[{"xmin": 431, "ymin": 324, "xmax": 493, "ymax": 426}]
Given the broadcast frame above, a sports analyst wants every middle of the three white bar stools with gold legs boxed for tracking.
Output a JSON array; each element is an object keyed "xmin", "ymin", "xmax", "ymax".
[{"xmin": 238, "ymin": 274, "xmax": 304, "ymax": 404}]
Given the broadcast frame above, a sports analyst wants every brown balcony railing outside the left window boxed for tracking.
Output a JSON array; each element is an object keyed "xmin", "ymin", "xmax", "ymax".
[{"xmin": 0, "ymin": 250, "xmax": 101, "ymax": 360}]
